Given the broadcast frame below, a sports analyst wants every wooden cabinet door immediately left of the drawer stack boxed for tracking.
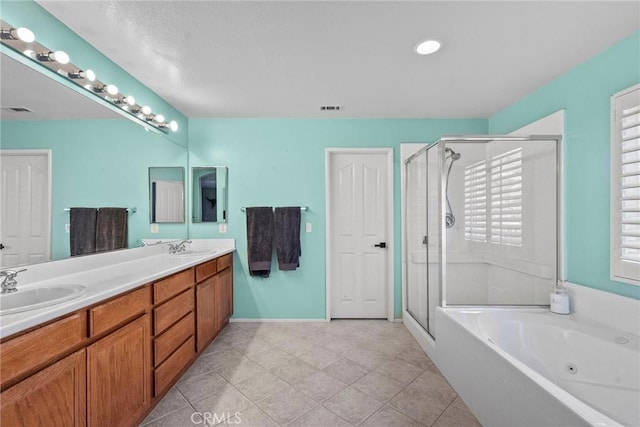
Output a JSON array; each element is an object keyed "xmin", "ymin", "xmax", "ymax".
[{"xmin": 87, "ymin": 314, "xmax": 151, "ymax": 426}]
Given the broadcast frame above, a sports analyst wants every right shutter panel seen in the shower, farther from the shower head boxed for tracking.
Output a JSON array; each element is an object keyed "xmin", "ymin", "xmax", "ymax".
[{"xmin": 490, "ymin": 148, "xmax": 522, "ymax": 246}]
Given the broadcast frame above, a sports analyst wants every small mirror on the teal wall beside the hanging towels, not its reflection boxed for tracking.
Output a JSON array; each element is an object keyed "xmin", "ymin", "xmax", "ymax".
[{"xmin": 191, "ymin": 166, "xmax": 227, "ymax": 223}]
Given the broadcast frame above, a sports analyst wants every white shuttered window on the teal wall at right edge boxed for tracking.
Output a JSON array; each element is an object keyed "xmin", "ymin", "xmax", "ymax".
[{"xmin": 611, "ymin": 86, "xmax": 640, "ymax": 285}]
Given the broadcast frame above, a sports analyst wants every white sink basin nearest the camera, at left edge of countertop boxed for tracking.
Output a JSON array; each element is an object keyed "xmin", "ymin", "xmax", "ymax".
[{"xmin": 0, "ymin": 285, "xmax": 87, "ymax": 315}]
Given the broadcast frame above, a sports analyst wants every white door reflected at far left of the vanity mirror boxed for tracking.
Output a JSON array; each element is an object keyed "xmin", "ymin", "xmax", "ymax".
[{"xmin": 0, "ymin": 150, "xmax": 51, "ymax": 268}]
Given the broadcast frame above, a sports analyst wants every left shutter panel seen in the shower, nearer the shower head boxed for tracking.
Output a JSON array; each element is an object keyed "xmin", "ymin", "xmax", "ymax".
[{"xmin": 464, "ymin": 160, "xmax": 487, "ymax": 242}]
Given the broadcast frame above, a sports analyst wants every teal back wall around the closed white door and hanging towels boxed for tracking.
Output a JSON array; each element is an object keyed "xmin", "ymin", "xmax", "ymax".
[{"xmin": 189, "ymin": 119, "xmax": 487, "ymax": 319}]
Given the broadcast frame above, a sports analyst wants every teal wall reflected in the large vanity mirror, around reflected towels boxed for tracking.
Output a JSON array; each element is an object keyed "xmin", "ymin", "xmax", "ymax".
[{"xmin": 0, "ymin": 119, "xmax": 188, "ymax": 260}]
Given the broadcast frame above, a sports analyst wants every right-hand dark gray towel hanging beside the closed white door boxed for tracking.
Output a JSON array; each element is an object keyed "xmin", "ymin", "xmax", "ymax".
[{"xmin": 276, "ymin": 207, "xmax": 302, "ymax": 270}]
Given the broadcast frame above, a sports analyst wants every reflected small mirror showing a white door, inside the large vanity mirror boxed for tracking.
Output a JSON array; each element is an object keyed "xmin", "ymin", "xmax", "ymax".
[{"xmin": 149, "ymin": 167, "xmax": 184, "ymax": 224}]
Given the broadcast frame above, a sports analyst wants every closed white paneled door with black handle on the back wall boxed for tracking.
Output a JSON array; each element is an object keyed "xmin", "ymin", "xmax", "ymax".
[{"xmin": 327, "ymin": 149, "xmax": 393, "ymax": 318}]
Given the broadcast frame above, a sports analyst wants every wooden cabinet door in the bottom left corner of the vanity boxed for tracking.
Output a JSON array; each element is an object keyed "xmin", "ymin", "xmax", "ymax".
[{"xmin": 0, "ymin": 350, "xmax": 86, "ymax": 427}]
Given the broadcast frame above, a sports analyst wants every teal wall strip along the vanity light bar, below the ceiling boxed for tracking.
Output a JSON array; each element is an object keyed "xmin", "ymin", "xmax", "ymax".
[{"xmin": 0, "ymin": 0, "xmax": 188, "ymax": 147}]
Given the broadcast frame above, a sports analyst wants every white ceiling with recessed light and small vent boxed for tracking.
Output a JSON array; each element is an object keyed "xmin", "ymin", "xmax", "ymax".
[{"xmin": 33, "ymin": 0, "xmax": 640, "ymax": 118}]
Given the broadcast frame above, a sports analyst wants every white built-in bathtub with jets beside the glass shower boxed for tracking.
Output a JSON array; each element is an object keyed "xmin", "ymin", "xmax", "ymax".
[{"xmin": 436, "ymin": 308, "xmax": 640, "ymax": 426}]
